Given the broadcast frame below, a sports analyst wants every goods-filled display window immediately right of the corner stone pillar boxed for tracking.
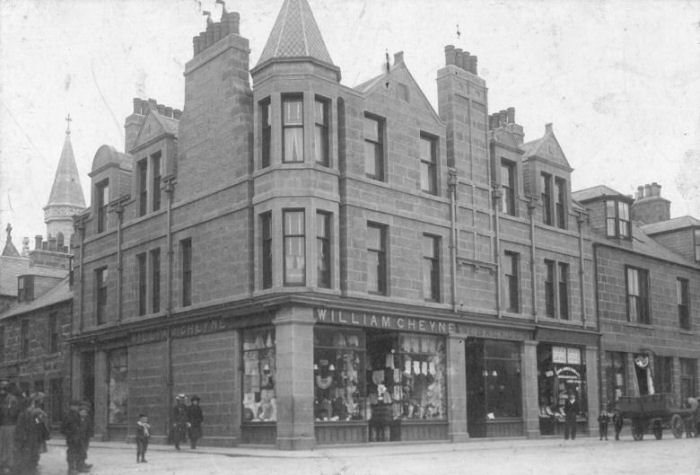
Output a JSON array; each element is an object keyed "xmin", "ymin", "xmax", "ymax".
[{"xmin": 314, "ymin": 328, "xmax": 366, "ymax": 422}]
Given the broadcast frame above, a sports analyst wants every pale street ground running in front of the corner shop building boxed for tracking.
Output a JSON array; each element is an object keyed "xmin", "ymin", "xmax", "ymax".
[{"xmin": 31, "ymin": 434, "xmax": 700, "ymax": 475}]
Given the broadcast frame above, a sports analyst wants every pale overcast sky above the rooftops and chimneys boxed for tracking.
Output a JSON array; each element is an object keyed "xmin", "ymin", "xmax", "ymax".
[{"xmin": 0, "ymin": 0, "xmax": 700, "ymax": 249}]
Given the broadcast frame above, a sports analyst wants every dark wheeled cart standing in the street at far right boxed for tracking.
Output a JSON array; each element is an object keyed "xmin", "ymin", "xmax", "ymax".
[{"xmin": 617, "ymin": 393, "xmax": 693, "ymax": 440}]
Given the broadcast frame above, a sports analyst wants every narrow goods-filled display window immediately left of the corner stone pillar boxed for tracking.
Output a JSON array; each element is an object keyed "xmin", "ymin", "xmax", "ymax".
[{"xmin": 242, "ymin": 327, "xmax": 277, "ymax": 423}]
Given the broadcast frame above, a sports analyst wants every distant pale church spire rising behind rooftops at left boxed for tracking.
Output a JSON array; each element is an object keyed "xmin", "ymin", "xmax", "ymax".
[{"xmin": 44, "ymin": 114, "xmax": 85, "ymax": 244}]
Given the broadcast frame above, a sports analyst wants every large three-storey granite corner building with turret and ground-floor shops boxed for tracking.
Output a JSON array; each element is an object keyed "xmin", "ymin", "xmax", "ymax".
[{"xmin": 71, "ymin": 0, "xmax": 599, "ymax": 449}]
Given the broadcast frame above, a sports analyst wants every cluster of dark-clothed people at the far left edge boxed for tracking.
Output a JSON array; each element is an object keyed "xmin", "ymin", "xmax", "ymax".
[{"xmin": 0, "ymin": 380, "xmax": 49, "ymax": 475}]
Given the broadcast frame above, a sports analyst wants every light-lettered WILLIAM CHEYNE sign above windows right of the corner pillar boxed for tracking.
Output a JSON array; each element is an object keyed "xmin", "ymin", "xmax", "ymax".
[{"xmin": 314, "ymin": 308, "xmax": 457, "ymax": 334}]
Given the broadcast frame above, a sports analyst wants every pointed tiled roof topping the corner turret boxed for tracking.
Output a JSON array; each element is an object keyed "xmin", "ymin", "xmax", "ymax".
[{"xmin": 255, "ymin": 0, "xmax": 338, "ymax": 74}]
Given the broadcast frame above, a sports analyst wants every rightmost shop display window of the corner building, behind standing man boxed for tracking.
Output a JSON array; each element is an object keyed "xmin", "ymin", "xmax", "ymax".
[{"xmin": 537, "ymin": 343, "xmax": 588, "ymax": 434}]
